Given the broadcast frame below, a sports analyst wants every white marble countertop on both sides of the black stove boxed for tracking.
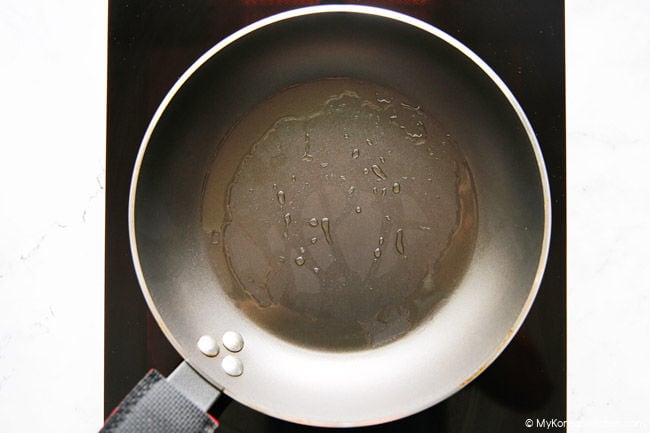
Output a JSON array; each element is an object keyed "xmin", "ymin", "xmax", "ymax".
[{"xmin": 0, "ymin": 0, "xmax": 650, "ymax": 433}]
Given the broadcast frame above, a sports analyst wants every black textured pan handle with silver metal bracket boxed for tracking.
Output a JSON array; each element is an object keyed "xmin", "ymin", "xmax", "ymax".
[{"xmin": 100, "ymin": 361, "xmax": 221, "ymax": 433}]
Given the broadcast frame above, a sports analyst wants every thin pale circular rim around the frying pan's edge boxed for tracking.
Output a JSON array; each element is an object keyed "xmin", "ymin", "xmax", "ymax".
[{"xmin": 128, "ymin": 5, "xmax": 552, "ymax": 427}]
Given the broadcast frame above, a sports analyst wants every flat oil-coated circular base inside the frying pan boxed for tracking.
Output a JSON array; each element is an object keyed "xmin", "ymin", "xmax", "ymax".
[{"xmin": 202, "ymin": 78, "xmax": 478, "ymax": 350}]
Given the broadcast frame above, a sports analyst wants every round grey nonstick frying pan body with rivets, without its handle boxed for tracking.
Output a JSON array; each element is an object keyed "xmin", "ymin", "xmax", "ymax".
[{"xmin": 117, "ymin": 6, "xmax": 551, "ymax": 426}]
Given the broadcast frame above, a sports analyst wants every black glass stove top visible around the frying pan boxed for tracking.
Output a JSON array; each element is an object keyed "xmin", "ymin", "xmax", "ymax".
[{"xmin": 104, "ymin": 0, "xmax": 566, "ymax": 433}]
